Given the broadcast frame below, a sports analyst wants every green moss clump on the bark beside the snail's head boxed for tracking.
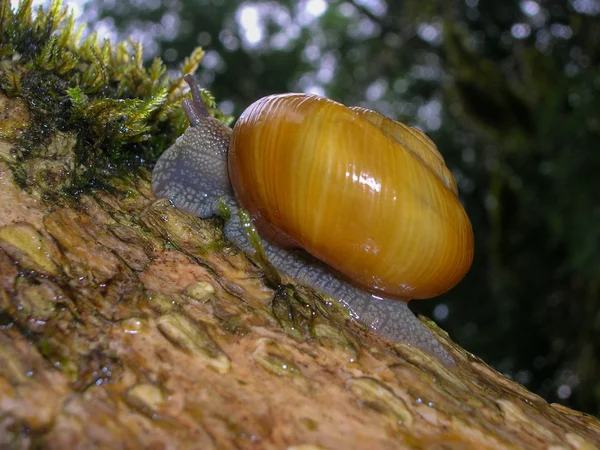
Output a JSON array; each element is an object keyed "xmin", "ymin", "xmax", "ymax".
[{"xmin": 0, "ymin": 0, "xmax": 231, "ymax": 195}]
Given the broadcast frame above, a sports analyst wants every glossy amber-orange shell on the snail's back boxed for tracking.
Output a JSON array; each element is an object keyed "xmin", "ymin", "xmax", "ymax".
[{"xmin": 229, "ymin": 94, "xmax": 473, "ymax": 299}]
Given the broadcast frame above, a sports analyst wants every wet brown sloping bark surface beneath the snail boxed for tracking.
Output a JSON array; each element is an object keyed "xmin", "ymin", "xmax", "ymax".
[{"xmin": 0, "ymin": 91, "xmax": 600, "ymax": 450}]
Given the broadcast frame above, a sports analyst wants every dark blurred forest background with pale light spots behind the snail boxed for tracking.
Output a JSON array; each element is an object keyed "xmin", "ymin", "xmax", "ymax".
[{"xmin": 39, "ymin": 0, "xmax": 600, "ymax": 415}]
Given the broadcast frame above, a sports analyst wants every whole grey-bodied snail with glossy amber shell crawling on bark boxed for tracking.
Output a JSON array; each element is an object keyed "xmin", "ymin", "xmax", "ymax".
[{"xmin": 152, "ymin": 75, "xmax": 473, "ymax": 365}]
